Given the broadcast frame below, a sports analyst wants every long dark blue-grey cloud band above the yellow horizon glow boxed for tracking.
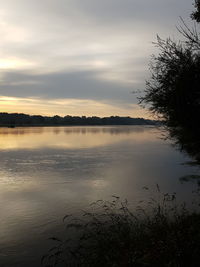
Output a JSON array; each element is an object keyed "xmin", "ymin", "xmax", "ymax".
[{"xmin": 0, "ymin": 70, "xmax": 143, "ymax": 104}]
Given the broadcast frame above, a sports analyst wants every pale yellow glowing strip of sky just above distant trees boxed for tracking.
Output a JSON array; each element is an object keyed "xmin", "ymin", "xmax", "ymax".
[{"xmin": 0, "ymin": 96, "xmax": 150, "ymax": 118}]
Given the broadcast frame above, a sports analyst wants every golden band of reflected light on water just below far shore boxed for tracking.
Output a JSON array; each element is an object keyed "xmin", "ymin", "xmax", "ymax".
[{"xmin": 0, "ymin": 127, "xmax": 158, "ymax": 150}]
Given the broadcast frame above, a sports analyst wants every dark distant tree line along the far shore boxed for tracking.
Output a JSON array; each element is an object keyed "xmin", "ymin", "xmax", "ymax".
[{"xmin": 0, "ymin": 113, "xmax": 158, "ymax": 127}]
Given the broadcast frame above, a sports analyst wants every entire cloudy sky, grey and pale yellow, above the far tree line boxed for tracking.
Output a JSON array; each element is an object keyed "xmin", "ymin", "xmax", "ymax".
[{"xmin": 0, "ymin": 0, "xmax": 193, "ymax": 118}]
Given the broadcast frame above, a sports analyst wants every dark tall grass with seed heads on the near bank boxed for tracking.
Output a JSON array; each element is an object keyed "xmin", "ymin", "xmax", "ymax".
[{"xmin": 42, "ymin": 187, "xmax": 200, "ymax": 267}]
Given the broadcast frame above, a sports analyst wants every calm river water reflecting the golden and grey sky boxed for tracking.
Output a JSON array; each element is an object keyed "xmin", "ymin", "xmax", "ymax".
[{"xmin": 0, "ymin": 126, "xmax": 198, "ymax": 267}]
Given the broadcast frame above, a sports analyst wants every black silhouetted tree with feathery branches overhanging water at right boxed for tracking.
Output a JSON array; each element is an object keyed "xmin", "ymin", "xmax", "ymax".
[{"xmin": 140, "ymin": 0, "xmax": 200, "ymax": 163}]
